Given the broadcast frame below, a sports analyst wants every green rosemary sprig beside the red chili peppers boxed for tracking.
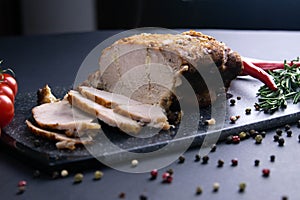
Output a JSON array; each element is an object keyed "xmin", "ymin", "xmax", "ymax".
[{"xmin": 254, "ymin": 57, "xmax": 300, "ymax": 113}]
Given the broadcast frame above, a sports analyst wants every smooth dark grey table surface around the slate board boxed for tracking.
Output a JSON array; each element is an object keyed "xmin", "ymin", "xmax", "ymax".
[{"xmin": 0, "ymin": 30, "xmax": 300, "ymax": 199}]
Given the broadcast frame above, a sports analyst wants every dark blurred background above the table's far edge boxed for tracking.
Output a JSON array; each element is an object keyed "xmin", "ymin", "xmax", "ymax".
[{"xmin": 0, "ymin": 0, "xmax": 300, "ymax": 36}]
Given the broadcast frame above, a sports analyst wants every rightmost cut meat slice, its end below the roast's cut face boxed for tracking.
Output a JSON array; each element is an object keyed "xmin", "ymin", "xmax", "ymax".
[{"xmin": 113, "ymin": 104, "xmax": 170, "ymax": 130}]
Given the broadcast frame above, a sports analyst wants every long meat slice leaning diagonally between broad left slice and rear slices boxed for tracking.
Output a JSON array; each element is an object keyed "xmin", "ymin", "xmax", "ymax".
[{"xmin": 67, "ymin": 90, "xmax": 142, "ymax": 133}]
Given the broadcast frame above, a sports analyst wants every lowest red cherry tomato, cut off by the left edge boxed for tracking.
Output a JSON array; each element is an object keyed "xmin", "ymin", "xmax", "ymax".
[{"xmin": 0, "ymin": 94, "xmax": 15, "ymax": 128}]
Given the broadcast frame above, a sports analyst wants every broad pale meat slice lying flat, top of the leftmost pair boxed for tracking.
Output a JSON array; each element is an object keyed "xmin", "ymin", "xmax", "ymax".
[{"xmin": 32, "ymin": 100, "xmax": 101, "ymax": 136}]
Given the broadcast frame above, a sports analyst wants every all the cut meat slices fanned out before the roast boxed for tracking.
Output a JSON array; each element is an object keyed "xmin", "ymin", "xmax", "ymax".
[{"xmin": 26, "ymin": 86, "xmax": 170, "ymax": 149}]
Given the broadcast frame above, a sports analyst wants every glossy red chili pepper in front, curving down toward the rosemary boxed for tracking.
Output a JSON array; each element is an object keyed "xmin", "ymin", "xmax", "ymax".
[{"xmin": 243, "ymin": 59, "xmax": 277, "ymax": 91}]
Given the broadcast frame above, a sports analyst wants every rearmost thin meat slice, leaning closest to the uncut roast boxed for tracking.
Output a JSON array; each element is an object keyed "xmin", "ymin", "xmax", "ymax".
[{"xmin": 78, "ymin": 86, "xmax": 141, "ymax": 108}]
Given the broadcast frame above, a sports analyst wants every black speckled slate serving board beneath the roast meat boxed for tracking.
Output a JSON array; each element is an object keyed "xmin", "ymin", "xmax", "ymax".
[{"xmin": 0, "ymin": 77, "xmax": 299, "ymax": 168}]
